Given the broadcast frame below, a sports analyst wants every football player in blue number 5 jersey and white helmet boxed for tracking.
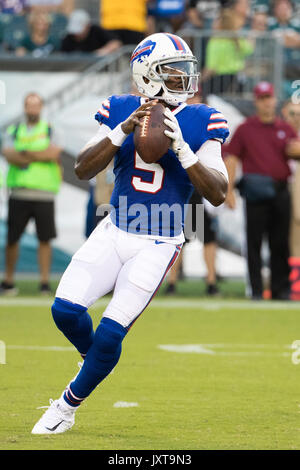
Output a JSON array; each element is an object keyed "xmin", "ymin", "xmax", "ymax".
[{"xmin": 32, "ymin": 33, "xmax": 229, "ymax": 434}]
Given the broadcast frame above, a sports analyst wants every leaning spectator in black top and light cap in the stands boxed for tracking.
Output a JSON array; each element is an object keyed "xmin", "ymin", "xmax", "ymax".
[{"xmin": 61, "ymin": 10, "xmax": 122, "ymax": 56}]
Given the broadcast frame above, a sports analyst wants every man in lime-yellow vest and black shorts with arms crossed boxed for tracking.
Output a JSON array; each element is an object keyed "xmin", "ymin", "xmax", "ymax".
[{"xmin": 1, "ymin": 93, "xmax": 61, "ymax": 295}]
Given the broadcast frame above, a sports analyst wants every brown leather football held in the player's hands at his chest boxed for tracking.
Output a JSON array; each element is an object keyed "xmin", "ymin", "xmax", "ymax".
[{"xmin": 134, "ymin": 103, "xmax": 171, "ymax": 163}]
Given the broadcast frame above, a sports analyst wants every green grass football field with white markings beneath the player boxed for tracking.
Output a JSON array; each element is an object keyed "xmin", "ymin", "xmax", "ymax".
[{"xmin": 0, "ymin": 282, "xmax": 300, "ymax": 450}]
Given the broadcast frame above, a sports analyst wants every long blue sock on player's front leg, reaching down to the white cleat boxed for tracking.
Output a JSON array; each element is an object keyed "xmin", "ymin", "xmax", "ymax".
[{"xmin": 64, "ymin": 318, "xmax": 128, "ymax": 406}]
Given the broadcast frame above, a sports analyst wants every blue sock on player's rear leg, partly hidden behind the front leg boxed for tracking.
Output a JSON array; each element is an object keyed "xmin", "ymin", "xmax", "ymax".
[{"xmin": 52, "ymin": 297, "xmax": 94, "ymax": 358}]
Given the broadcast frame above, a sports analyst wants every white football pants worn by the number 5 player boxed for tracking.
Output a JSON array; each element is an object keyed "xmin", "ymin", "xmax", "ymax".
[{"xmin": 56, "ymin": 216, "xmax": 182, "ymax": 328}]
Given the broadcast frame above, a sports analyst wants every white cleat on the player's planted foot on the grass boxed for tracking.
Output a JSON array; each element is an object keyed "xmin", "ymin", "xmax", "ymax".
[{"xmin": 31, "ymin": 399, "xmax": 76, "ymax": 434}]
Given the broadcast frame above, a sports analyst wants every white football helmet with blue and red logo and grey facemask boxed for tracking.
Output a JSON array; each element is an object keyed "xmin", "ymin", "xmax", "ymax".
[{"xmin": 130, "ymin": 33, "xmax": 199, "ymax": 106}]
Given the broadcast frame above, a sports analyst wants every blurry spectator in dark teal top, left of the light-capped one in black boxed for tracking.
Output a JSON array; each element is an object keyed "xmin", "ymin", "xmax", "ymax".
[{"xmin": 15, "ymin": 12, "xmax": 60, "ymax": 57}]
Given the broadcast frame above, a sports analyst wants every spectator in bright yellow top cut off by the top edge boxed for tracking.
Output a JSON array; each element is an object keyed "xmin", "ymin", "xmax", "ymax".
[{"xmin": 100, "ymin": 0, "xmax": 148, "ymax": 45}]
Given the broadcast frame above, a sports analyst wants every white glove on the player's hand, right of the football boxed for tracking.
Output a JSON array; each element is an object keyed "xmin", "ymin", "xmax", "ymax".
[{"xmin": 164, "ymin": 108, "xmax": 198, "ymax": 170}]
